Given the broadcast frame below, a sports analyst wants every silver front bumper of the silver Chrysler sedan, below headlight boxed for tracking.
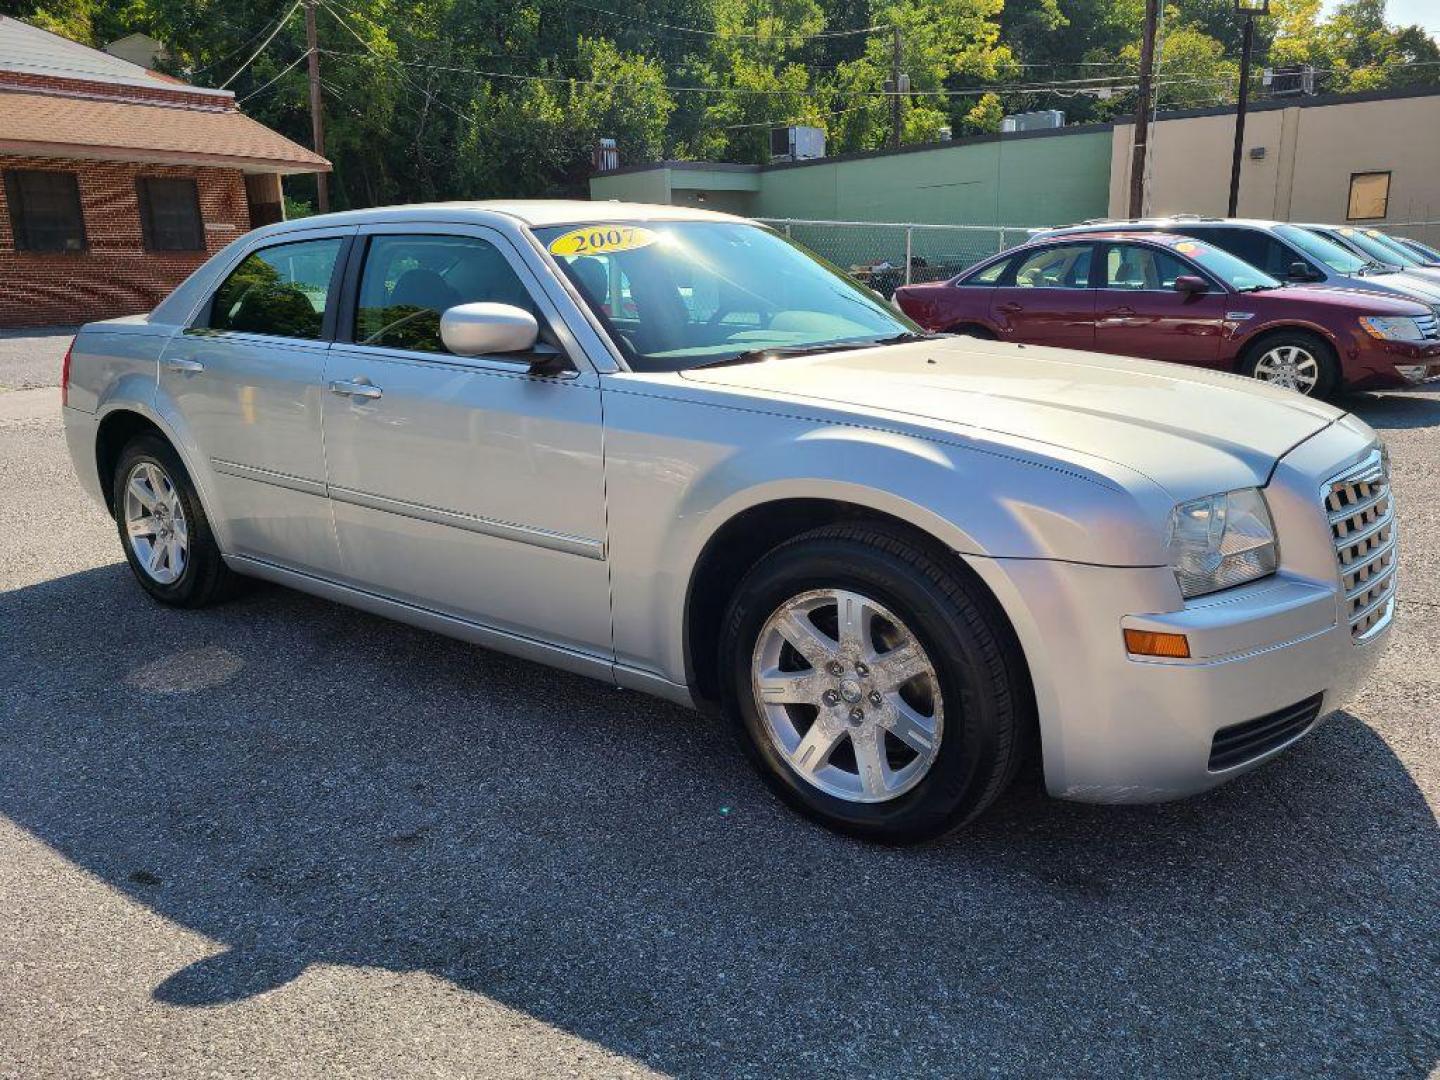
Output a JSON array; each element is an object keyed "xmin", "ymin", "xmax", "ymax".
[{"xmin": 982, "ymin": 420, "xmax": 1394, "ymax": 802}]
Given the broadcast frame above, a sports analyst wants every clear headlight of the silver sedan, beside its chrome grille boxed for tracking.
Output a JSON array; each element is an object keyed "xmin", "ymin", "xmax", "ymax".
[{"xmin": 1166, "ymin": 488, "xmax": 1280, "ymax": 599}]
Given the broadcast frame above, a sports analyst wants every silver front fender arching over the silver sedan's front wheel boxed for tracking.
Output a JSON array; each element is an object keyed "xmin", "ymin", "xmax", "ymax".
[{"xmin": 606, "ymin": 393, "xmax": 1172, "ymax": 694}]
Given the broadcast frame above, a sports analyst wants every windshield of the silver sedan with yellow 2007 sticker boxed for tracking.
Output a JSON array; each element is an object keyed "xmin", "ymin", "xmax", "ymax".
[{"xmin": 534, "ymin": 222, "xmax": 917, "ymax": 372}]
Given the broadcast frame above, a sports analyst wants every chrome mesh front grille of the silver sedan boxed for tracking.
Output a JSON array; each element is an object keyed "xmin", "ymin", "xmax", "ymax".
[{"xmin": 1322, "ymin": 449, "xmax": 1400, "ymax": 642}]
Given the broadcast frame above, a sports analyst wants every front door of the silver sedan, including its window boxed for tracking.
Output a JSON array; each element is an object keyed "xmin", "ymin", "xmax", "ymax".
[{"xmin": 324, "ymin": 226, "xmax": 611, "ymax": 655}]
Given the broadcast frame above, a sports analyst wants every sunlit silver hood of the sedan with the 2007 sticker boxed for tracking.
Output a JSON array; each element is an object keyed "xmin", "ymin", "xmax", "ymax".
[{"xmin": 684, "ymin": 337, "xmax": 1344, "ymax": 498}]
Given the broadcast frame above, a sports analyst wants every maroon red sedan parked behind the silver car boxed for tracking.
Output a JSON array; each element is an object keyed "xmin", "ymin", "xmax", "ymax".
[{"xmin": 896, "ymin": 232, "xmax": 1440, "ymax": 396}]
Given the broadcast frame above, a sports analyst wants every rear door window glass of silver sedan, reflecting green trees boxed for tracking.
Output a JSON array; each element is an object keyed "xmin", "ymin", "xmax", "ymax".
[{"xmin": 207, "ymin": 236, "xmax": 344, "ymax": 340}]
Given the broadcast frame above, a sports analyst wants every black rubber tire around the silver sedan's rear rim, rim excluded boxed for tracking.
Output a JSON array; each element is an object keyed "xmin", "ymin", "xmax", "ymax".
[{"xmin": 111, "ymin": 435, "xmax": 239, "ymax": 608}]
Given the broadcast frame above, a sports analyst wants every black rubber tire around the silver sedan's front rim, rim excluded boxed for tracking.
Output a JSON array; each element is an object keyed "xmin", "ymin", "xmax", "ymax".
[{"xmin": 720, "ymin": 524, "xmax": 1034, "ymax": 844}]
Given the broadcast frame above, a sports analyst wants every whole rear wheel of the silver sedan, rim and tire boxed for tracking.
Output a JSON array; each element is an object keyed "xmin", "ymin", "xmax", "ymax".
[{"xmin": 112, "ymin": 435, "xmax": 236, "ymax": 608}]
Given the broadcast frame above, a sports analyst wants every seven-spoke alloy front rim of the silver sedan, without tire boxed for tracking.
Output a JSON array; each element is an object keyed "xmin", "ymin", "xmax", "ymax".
[{"xmin": 750, "ymin": 589, "xmax": 945, "ymax": 802}]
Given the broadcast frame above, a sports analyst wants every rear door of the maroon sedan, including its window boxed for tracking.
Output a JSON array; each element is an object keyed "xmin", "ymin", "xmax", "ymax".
[{"xmin": 991, "ymin": 240, "xmax": 1094, "ymax": 348}]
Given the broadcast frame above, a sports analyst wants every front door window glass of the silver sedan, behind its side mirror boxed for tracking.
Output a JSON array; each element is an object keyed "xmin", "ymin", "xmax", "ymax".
[{"xmin": 354, "ymin": 233, "xmax": 537, "ymax": 353}]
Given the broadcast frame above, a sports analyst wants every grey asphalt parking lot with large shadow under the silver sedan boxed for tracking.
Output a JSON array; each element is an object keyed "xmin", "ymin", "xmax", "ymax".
[{"xmin": 0, "ymin": 337, "xmax": 1440, "ymax": 1080}]
